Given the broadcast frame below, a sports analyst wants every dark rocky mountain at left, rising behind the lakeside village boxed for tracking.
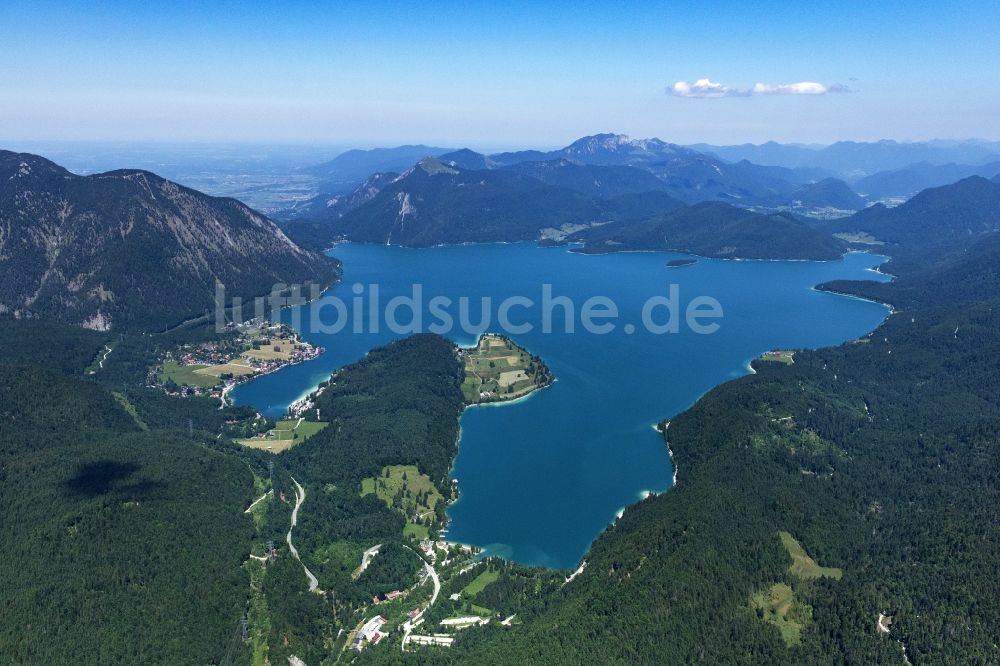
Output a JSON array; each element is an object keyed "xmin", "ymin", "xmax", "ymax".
[{"xmin": 0, "ymin": 151, "xmax": 338, "ymax": 330}]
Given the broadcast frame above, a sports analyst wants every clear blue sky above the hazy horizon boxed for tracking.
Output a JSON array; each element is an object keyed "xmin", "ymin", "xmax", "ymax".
[{"xmin": 0, "ymin": 0, "xmax": 1000, "ymax": 148}]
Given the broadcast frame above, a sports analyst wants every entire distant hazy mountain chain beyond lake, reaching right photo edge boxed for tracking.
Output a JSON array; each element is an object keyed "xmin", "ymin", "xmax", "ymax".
[{"xmin": 277, "ymin": 133, "xmax": 1000, "ymax": 228}]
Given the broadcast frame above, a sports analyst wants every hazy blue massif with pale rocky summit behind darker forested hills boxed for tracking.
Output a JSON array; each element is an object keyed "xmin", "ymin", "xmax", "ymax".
[{"xmin": 278, "ymin": 134, "xmax": 865, "ymax": 222}]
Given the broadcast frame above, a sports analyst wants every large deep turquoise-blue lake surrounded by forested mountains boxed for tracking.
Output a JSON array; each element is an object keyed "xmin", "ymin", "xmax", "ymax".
[{"xmin": 232, "ymin": 244, "xmax": 888, "ymax": 567}]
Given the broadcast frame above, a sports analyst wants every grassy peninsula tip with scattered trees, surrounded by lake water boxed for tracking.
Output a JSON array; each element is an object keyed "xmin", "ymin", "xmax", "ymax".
[{"xmin": 462, "ymin": 335, "xmax": 547, "ymax": 404}]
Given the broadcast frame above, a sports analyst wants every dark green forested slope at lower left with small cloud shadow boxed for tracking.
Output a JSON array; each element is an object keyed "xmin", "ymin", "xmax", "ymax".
[{"xmin": 0, "ymin": 321, "xmax": 254, "ymax": 665}]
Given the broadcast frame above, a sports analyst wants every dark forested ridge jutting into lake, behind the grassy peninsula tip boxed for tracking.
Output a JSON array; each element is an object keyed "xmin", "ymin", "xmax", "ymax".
[{"xmin": 250, "ymin": 335, "xmax": 464, "ymax": 664}]
